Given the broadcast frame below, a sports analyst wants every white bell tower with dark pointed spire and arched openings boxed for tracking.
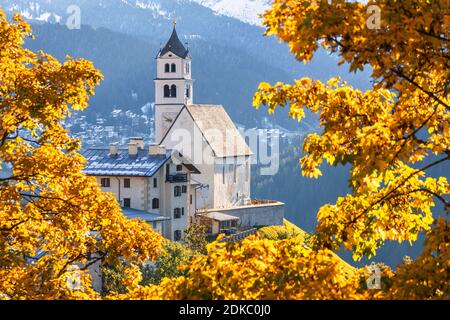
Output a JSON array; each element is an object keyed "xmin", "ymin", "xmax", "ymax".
[{"xmin": 155, "ymin": 21, "xmax": 194, "ymax": 143}]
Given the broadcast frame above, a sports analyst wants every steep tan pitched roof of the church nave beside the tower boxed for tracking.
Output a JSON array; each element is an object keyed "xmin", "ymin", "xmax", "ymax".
[{"xmin": 162, "ymin": 104, "xmax": 253, "ymax": 158}]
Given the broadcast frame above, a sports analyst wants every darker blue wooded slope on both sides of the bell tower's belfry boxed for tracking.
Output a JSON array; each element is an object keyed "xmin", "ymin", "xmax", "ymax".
[{"xmin": 26, "ymin": 24, "xmax": 298, "ymax": 128}]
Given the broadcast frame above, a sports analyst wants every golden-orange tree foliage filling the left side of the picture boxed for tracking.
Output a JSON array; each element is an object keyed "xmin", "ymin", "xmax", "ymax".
[{"xmin": 0, "ymin": 11, "xmax": 162, "ymax": 299}]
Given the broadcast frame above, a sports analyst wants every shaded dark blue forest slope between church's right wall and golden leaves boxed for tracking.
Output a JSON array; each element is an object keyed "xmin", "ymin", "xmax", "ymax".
[{"xmin": 252, "ymin": 139, "xmax": 450, "ymax": 268}]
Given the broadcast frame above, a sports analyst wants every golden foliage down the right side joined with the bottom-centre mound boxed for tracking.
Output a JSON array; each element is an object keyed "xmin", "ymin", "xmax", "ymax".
[{"xmin": 122, "ymin": 0, "xmax": 450, "ymax": 299}]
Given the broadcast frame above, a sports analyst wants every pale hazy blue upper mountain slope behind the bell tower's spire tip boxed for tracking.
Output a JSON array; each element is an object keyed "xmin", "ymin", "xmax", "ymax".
[{"xmin": 0, "ymin": 0, "xmax": 368, "ymax": 89}]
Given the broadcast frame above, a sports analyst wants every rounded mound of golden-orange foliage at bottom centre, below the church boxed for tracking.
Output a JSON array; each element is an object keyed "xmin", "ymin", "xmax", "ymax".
[{"xmin": 122, "ymin": 237, "xmax": 365, "ymax": 300}]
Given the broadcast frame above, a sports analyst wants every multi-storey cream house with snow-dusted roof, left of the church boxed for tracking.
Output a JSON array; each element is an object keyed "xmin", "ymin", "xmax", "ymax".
[{"xmin": 84, "ymin": 138, "xmax": 199, "ymax": 241}]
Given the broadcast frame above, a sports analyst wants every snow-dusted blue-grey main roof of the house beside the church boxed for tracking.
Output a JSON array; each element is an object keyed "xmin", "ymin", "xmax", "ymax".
[{"xmin": 83, "ymin": 149, "xmax": 171, "ymax": 177}]
